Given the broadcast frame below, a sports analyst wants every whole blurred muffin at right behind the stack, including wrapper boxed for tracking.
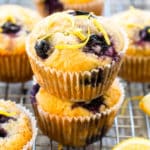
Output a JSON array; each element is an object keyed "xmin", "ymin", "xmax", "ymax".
[{"xmin": 112, "ymin": 8, "xmax": 150, "ymax": 82}]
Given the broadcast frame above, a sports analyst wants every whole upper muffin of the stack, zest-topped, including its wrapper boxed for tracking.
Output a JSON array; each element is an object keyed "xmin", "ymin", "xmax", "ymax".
[{"xmin": 27, "ymin": 11, "xmax": 127, "ymax": 101}]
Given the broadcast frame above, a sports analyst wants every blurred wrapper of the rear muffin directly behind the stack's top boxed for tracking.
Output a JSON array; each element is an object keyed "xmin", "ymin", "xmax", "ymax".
[{"xmin": 61, "ymin": 0, "xmax": 104, "ymax": 15}]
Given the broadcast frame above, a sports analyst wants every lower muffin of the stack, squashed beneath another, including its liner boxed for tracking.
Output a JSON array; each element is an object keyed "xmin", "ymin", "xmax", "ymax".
[{"xmin": 31, "ymin": 81, "xmax": 124, "ymax": 147}]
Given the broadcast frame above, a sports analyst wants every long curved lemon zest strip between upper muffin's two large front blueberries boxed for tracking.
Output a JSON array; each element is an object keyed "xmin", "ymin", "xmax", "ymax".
[{"xmin": 55, "ymin": 27, "xmax": 90, "ymax": 50}]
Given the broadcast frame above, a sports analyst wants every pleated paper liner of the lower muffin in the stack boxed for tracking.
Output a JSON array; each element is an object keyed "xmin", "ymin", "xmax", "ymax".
[{"xmin": 32, "ymin": 79, "xmax": 124, "ymax": 147}]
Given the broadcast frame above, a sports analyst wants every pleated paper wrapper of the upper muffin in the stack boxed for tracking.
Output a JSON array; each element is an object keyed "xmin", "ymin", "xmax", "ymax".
[{"xmin": 29, "ymin": 56, "xmax": 122, "ymax": 102}]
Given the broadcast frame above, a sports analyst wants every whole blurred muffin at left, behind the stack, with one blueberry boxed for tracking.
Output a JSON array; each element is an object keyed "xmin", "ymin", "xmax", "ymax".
[{"xmin": 0, "ymin": 5, "xmax": 40, "ymax": 82}]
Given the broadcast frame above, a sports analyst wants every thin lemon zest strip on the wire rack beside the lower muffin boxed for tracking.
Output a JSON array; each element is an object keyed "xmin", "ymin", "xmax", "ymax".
[{"xmin": 121, "ymin": 96, "xmax": 143, "ymax": 115}]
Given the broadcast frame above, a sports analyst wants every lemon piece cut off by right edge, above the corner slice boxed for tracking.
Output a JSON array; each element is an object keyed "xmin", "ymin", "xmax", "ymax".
[{"xmin": 139, "ymin": 93, "xmax": 150, "ymax": 116}]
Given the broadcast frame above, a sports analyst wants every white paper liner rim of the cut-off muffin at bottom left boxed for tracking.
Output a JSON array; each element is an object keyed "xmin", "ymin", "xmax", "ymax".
[{"xmin": 17, "ymin": 104, "xmax": 38, "ymax": 150}]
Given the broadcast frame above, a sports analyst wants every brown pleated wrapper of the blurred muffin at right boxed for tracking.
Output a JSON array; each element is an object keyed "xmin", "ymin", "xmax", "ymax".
[{"xmin": 119, "ymin": 56, "xmax": 150, "ymax": 82}]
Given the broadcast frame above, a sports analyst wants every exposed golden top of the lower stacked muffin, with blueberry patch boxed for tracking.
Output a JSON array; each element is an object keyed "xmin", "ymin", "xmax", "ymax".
[{"xmin": 32, "ymin": 79, "xmax": 123, "ymax": 117}]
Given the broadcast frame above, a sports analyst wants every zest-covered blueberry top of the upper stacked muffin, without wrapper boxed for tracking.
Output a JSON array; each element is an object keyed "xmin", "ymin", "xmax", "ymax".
[{"xmin": 27, "ymin": 11, "xmax": 126, "ymax": 72}]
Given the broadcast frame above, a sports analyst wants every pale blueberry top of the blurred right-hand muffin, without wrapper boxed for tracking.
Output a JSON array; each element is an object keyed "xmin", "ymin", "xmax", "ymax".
[{"xmin": 112, "ymin": 7, "xmax": 150, "ymax": 56}]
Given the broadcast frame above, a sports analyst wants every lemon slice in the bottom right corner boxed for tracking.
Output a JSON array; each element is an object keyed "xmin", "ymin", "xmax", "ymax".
[{"xmin": 112, "ymin": 137, "xmax": 150, "ymax": 150}]
